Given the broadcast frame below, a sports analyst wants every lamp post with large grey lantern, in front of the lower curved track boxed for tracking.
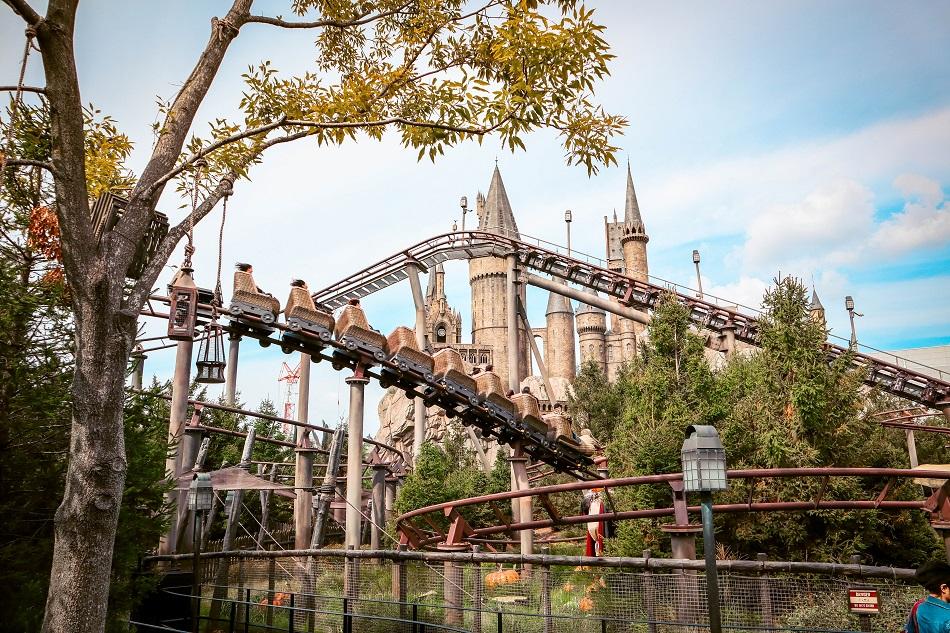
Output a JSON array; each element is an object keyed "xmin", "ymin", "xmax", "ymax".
[{"xmin": 680, "ymin": 424, "xmax": 729, "ymax": 633}]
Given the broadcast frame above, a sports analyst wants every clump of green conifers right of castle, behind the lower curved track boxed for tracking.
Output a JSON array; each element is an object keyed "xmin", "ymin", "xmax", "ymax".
[{"xmin": 600, "ymin": 277, "xmax": 940, "ymax": 565}]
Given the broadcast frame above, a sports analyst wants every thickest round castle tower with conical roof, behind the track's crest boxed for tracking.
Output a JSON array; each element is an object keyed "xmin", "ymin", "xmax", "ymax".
[{"xmin": 468, "ymin": 165, "xmax": 530, "ymax": 386}]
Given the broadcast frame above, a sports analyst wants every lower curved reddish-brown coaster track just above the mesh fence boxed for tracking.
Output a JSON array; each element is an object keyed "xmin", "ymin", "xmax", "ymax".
[{"xmin": 396, "ymin": 468, "xmax": 950, "ymax": 549}]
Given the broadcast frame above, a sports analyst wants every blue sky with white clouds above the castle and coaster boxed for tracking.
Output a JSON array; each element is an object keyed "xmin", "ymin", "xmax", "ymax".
[{"xmin": 0, "ymin": 0, "xmax": 950, "ymax": 426}]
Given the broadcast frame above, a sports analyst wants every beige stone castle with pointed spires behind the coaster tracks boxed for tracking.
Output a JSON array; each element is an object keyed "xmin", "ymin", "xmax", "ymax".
[{"xmin": 379, "ymin": 164, "xmax": 650, "ymax": 452}]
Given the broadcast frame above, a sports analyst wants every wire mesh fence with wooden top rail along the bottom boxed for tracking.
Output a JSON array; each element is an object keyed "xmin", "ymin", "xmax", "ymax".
[{"xmin": 141, "ymin": 551, "xmax": 921, "ymax": 633}]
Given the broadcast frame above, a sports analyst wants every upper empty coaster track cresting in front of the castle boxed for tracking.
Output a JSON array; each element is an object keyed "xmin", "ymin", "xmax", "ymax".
[{"xmin": 313, "ymin": 231, "xmax": 950, "ymax": 412}]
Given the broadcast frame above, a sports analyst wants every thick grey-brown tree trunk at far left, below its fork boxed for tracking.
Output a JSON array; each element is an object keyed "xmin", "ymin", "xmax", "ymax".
[{"xmin": 43, "ymin": 296, "xmax": 135, "ymax": 632}]
